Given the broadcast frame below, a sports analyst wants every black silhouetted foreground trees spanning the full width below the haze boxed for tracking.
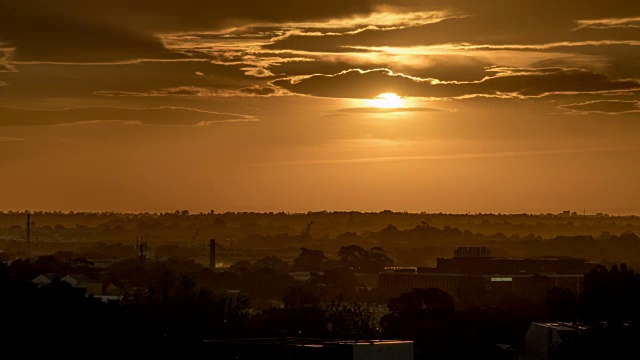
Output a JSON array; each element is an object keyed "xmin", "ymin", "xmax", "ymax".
[{"xmin": 0, "ymin": 256, "xmax": 640, "ymax": 359}]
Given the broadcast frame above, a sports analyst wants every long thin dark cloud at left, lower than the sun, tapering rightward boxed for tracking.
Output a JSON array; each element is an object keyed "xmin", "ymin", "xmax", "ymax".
[{"xmin": 0, "ymin": 107, "xmax": 258, "ymax": 127}]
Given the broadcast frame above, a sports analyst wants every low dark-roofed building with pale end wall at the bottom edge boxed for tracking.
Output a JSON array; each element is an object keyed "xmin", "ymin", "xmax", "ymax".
[{"xmin": 204, "ymin": 338, "xmax": 414, "ymax": 360}]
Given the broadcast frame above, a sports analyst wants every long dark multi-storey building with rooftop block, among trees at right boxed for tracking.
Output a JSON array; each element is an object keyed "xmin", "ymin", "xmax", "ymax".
[{"xmin": 379, "ymin": 247, "xmax": 595, "ymax": 300}]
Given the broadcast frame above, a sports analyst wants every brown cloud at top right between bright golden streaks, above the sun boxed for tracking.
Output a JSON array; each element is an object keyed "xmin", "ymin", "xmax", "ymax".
[{"xmin": 267, "ymin": 0, "xmax": 640, "ymax": 52}]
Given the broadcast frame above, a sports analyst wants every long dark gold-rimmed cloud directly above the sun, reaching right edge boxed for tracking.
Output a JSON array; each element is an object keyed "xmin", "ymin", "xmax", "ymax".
[{"xmin": 272, "ymin": 68, "xmax": 640, "ymax": 99}]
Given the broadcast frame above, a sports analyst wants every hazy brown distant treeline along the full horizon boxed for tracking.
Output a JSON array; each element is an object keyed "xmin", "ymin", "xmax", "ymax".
[{"xmin": 0, "ymin": 212, "xmax": 640, "ymax": 267}]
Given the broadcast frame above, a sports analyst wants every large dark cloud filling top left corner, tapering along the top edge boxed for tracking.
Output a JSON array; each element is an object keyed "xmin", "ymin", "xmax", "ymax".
[{"xmin": 0, "ymin": 0, "xmax": 372, "ymax": 63}]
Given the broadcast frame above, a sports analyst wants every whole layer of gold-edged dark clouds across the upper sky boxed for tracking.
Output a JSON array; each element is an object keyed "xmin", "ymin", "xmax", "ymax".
[{"xmin": 0, "ymin": 0, "xmax": 640, "ymax": 107}]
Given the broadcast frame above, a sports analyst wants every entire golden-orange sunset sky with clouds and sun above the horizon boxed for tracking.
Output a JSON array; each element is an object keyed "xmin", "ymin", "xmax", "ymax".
[{"xmin": 0, "ymin": 0, "xmax": 640, "ymax": 214}]
